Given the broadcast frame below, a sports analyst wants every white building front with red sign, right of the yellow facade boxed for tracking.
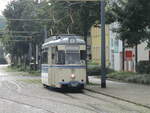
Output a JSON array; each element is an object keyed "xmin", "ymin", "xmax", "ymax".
[{"xmin": 109, "ymin": 23, "xmax": 150, "ymax": 72}]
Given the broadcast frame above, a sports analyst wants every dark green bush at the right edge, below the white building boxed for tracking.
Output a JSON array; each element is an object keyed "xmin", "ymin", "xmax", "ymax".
[{"xmin": 137, "ymin": 61, "xmax": 150, "ymax": 74}]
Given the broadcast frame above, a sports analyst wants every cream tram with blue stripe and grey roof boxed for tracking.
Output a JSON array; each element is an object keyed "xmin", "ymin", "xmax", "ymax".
[{"xmin": 41, "ymin": 35, "xmax": 86, "ymax": 89}]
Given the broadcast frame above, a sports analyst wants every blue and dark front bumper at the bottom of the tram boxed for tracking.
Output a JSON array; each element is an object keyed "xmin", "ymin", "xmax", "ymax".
[{"xmin": 60, "ymin": 81, "xmax": 85, "ymax": 89}]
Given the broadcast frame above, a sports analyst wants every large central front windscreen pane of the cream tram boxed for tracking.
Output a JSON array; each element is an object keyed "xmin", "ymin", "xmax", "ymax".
[{"xmin": 66, "ymin": 52, "xmax": 80, "ymax": 64}]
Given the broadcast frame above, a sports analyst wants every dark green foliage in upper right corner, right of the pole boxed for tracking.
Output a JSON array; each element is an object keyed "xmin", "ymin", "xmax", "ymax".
[{"xmin": 113, "ymin": 0, "xmax": 150, "ymax": 46}]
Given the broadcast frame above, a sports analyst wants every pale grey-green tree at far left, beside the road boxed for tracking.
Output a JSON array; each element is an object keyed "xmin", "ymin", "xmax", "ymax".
[{"xmin": 3, "ymin": 0, "xmax": 44, "ymax": 67}]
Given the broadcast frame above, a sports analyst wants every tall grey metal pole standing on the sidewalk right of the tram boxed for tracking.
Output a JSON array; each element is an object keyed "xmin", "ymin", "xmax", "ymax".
[{"xmin": 101, "ymin": 0, "xmax": 106, "ymax": 88}]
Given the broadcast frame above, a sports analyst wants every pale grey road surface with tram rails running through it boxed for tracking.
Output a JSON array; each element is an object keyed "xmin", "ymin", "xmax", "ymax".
[{"xmin": 0, "ymin": 65, "xmax": 150, "ymax": 113}]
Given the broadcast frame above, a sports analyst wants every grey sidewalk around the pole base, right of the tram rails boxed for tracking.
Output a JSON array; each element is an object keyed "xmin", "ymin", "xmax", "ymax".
[{"xmin": 86, "ymin": 77, "xmax": 150, "ymax": 108}]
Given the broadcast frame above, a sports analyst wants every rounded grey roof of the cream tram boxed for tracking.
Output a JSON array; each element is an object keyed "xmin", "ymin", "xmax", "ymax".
[{"xmin": 42, "ymin": 35, "xmax": 85, "ymax": 47}]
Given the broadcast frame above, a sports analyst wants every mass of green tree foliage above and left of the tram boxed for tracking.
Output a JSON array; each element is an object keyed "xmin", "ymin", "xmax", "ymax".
[{"xmin": 3, "ymin": 0, "xmax": 112, "ymax": 71}]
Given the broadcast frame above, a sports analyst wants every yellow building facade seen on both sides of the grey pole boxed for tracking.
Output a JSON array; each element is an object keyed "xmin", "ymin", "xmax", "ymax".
[{"xmin": 91, "ymin": 25, "xmax": 110, "ymax": 66}]
